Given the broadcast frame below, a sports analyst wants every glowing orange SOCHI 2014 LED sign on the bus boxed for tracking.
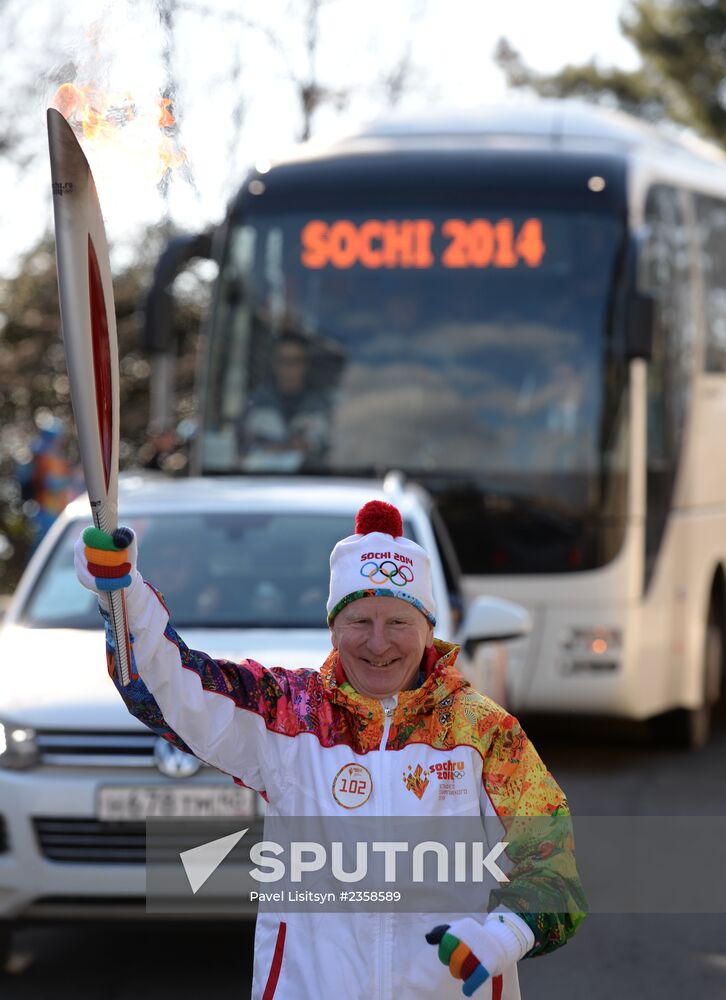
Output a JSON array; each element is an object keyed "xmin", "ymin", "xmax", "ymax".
[{"xmin": 301, "ymin": 218, "xmax": 546, "ymax": 269}]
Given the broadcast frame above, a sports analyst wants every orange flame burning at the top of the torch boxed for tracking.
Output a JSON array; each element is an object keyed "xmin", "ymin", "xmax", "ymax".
[{"xmin": 52, "ymin": 83, "xmax": 186, "ymax": 181}]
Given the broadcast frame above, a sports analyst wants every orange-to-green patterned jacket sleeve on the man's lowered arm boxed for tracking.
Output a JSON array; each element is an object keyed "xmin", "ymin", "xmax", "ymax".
[{"xmin": 483, "ymin": 715, "xmax": 587, "ymax": 958}]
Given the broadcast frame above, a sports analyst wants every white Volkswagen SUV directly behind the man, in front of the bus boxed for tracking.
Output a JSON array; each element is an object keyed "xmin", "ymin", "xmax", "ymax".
[{"xmin": 0, "ymin": 476, "xmax": 528, "ymax": 967}]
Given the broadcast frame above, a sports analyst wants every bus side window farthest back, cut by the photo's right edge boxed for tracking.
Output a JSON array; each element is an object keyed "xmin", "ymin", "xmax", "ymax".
[{"xmin": 696, "ymin": 196, "xmax": 726, "ymax": 372}]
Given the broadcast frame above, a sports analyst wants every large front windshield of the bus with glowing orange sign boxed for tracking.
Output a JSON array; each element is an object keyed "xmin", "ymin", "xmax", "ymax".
[{"xmin": 201, "ymin": 204, "xmax": 625, "ymax": 573}]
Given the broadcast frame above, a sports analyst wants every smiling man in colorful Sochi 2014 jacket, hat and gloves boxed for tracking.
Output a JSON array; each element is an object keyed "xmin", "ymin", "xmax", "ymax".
[{"xmin": 75, "ymin": 501, "xmax": 585, "ymax": 1000}]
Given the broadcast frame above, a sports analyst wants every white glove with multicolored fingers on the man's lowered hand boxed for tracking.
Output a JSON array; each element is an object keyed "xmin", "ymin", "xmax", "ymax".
[{"xmin": 426, "ymin": 913, "xmax": 534, "ymax": 997}]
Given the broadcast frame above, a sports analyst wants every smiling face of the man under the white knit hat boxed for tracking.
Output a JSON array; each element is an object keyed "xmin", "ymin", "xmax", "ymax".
[{"xmin": 330, "ymin": 597, "xmax": 434, "ymax": 698}]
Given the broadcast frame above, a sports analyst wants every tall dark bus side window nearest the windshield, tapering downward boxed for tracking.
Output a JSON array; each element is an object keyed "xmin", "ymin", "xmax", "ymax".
[{"xmin": 640, "ymin": 185, "xmax": 695, "ymax": 585}]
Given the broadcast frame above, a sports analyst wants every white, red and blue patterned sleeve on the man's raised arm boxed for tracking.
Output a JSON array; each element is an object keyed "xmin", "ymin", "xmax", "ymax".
[{"xmin": 104, "ymin": 577, "xmax": 316, "ymax": 791}]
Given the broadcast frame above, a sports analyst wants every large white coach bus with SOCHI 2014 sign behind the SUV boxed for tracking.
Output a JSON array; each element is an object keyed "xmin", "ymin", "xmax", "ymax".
[{"xmin": 149, "ymin": 102, "xmax": 726, "ymax": 746}]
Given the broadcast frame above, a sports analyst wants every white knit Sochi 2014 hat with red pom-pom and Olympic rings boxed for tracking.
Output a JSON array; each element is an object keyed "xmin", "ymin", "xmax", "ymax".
[{"xmin": 327, "ymin": 500, "xmax": 436, "ymax": 625}]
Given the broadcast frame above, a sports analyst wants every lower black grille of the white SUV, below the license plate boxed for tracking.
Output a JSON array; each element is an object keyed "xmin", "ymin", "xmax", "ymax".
[{"xmin": 33, "ymin": 816, "xmax": 264, "ymax": 865}]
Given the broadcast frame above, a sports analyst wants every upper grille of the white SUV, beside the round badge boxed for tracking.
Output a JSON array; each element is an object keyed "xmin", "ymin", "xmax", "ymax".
[{"xmin": 36, "ymin": 729, "xmax": 185, "ymax": 767}]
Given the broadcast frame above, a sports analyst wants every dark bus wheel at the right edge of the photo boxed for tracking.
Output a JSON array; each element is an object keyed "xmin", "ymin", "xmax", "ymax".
[{"xmin": 653, "ymin": 594, "xmax": 725, "ymax": 750}]
